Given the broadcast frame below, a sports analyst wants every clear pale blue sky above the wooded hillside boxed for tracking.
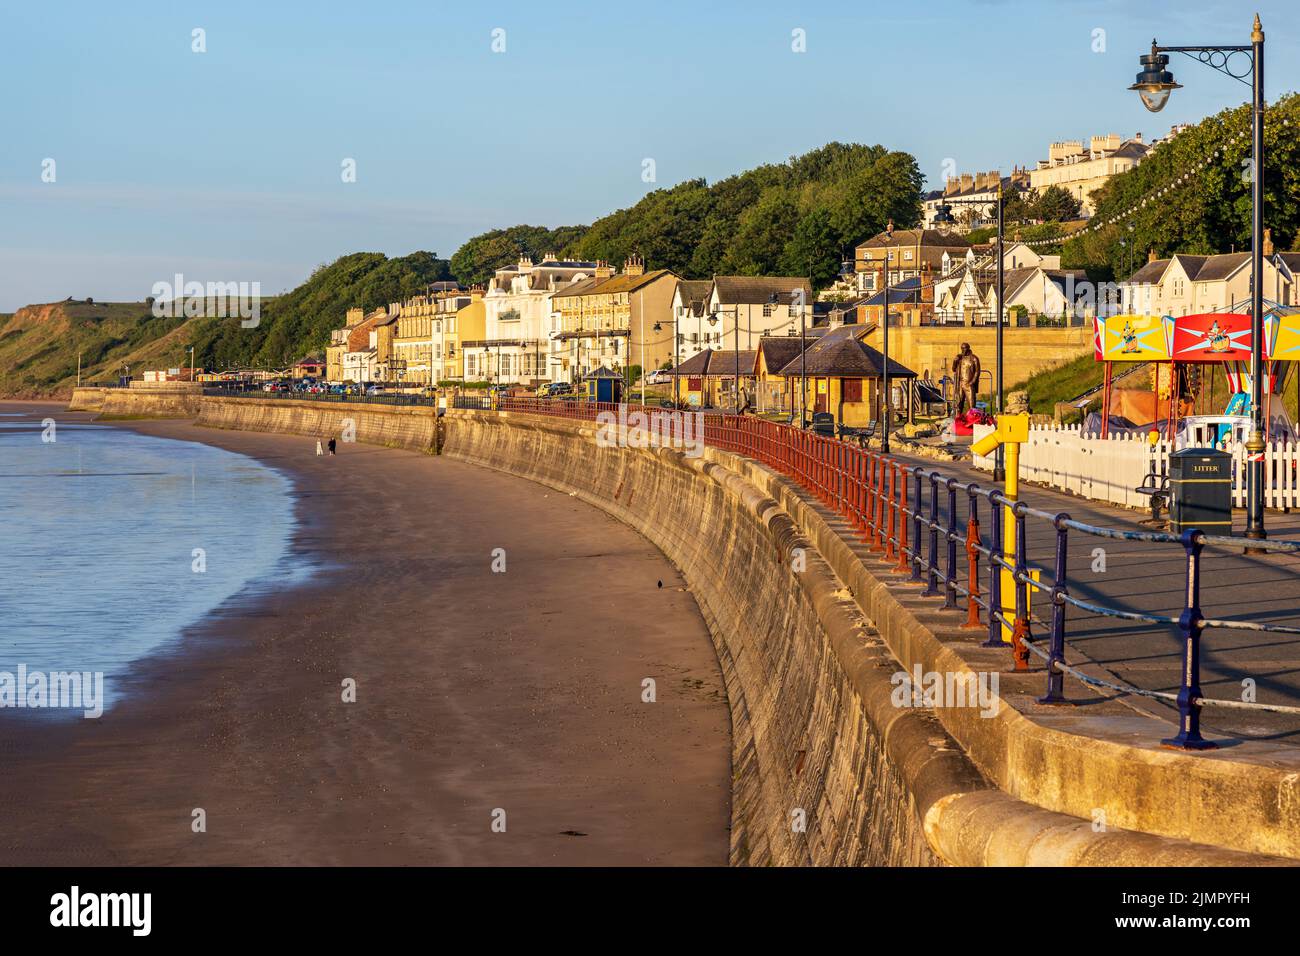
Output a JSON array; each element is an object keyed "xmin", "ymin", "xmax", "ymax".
[{"xmin": 0, "ymin": 0, "xmax": 1300, "ymax": 312}]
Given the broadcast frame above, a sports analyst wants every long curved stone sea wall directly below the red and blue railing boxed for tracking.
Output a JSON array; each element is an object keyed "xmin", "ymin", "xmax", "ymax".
[{"xmin": 443, "ymin": 411, "xmax": 1287, "ymax": 866}]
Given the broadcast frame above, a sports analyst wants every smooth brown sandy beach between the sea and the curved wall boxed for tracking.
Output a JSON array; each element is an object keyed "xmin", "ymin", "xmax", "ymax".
[{"xmin": 0, "ymin": 403, "xmax": 731, "ymax": 866}]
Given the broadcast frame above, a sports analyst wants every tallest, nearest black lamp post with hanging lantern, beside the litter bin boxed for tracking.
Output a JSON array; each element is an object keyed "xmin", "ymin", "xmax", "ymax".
[{"xmin": 1128, "ymin": 14, "xmax": 1268, "ymax": 538}]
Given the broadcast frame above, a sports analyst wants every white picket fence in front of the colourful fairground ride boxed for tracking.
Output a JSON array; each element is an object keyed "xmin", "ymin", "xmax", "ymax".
[{"xmin": 974, "ymin": 425, "xmax": 1300, "ymax": 510}]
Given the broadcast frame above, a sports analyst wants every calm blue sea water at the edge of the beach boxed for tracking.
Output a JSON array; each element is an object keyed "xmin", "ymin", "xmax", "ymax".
[{"xmin": 0, "ymin": 412, "xmax": 303, "ymax": 717}]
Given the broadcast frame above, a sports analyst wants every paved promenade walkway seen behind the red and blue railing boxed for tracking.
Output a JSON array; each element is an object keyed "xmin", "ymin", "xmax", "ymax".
[{"xmin": 893, "ymin": 442, "xmax": 1300, "ymax": 747}]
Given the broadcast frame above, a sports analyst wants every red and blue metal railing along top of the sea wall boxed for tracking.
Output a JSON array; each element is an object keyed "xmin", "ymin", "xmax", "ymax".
[{"xmin": 488, "ymin": 398, "xmax": 1300, "ymax": 750}]
